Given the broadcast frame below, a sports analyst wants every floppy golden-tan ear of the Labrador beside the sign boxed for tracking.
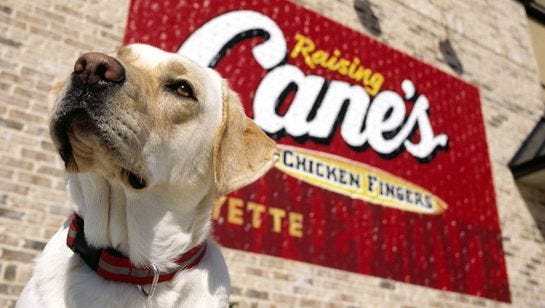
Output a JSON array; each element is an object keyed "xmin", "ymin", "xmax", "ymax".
[{"xmin": 214, "ymin": 86, "xmax": 278, "ymax": 196}]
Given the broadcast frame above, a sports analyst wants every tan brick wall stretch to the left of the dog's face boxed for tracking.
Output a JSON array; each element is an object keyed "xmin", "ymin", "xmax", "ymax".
[{"xmin": 0, "ymin": 0, "xmax": 128, "ymax": 307}]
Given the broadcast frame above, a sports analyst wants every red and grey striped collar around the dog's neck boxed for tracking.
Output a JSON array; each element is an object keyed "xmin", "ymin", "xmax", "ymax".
[{"xmin": 66, "ymin": 213, "xmax": 206, "ymax": 286}]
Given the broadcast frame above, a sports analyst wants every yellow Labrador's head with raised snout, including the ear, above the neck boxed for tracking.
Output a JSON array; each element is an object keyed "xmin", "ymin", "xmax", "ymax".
[{"xmin": 50, "ymin": 44, "xmax": 275, "ymax": 194}]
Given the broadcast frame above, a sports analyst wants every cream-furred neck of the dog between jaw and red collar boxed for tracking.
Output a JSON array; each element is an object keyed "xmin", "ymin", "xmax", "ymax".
[{"xmin": 68, "ymin": 173, "xmax": 214, "ymax": 270}]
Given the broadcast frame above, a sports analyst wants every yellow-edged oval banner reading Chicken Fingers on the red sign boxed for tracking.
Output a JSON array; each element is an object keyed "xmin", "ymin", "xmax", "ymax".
[{"xmin": 275, "ymin": 145, "xmax": 448, "ymax": 215}]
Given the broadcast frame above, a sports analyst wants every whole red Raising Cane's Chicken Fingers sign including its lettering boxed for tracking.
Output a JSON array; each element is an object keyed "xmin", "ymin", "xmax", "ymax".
[{"xmin": 125, "ymin": 0, "xmax": 510, "ymax": 301}]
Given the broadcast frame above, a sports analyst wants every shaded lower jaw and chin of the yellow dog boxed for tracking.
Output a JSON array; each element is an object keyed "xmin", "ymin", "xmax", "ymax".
[{"xmin": 50, "ymin": 109, "xmax": 146, "ymax": 189}]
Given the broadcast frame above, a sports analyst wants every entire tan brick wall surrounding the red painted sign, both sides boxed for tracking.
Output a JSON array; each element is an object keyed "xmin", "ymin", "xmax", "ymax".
[{"xmin": 0, "ymin": 0, "xmax": 545, "ymax": 307}]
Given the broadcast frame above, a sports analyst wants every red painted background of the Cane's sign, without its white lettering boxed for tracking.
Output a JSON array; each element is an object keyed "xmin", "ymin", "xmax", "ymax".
[{"xmin": 125, "ymin": 0, "xmax": 510, "ymax": 301}]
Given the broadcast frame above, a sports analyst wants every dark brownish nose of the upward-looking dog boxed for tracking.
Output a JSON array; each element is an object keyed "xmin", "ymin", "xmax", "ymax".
[{"xmin": 74, "ymin": 52, "xmax": 125, "ymax": 86}]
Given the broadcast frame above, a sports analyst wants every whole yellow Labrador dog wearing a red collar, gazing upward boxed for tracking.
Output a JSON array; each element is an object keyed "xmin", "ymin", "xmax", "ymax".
[{"xmin": 17, "ymin": 44, "xmax": 276, "ymax": 308}]
